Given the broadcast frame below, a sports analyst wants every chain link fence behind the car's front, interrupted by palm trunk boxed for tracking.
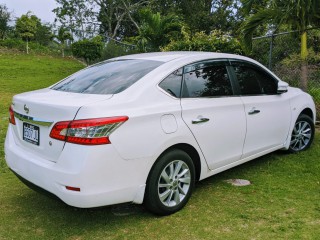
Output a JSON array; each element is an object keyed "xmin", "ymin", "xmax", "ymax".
[{"xmin": 251, "ymin": 30, "xmax": 320, "ymax": 121}]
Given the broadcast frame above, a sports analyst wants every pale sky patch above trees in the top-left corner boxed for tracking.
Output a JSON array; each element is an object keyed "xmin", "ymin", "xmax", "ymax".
[{"xmin": 0, "ymin": 0, "xmax": 57, "ymax": 23}]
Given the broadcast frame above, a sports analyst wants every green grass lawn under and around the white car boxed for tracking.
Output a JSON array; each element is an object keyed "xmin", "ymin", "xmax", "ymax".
[{"xmin": 0, "ymin": 49, "xmax": 320, "ymax": 240}]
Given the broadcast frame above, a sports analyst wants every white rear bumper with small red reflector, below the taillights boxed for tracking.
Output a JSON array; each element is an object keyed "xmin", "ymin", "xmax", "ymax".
[{"xmin": 5, "ymin": 126, "xmax": 149, "ymax": 208}]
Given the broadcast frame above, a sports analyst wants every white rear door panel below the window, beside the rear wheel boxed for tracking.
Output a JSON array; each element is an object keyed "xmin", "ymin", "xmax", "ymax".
[{"xmin": 181, "ymin": 97, "xmax": 246, "ymax": 169}]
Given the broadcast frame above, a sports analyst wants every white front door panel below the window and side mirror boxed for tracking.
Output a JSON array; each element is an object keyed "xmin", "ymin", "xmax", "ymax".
[{"xmin": 242, "ymin": 93, "xmax": 291, "ymax": 158}]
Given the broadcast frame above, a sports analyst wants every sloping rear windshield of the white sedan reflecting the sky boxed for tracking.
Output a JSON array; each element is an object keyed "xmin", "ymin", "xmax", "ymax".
[{"xmin": 51, "ymin": 59, "xmax": 163, "ymax": 94}]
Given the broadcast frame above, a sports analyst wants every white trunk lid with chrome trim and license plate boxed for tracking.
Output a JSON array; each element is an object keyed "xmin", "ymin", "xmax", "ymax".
[{"xmin": 12, "ymin": 89, "xmax": 112, "ymax": 162}]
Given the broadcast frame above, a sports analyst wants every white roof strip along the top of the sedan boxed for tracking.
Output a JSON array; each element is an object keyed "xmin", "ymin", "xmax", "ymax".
[{"xmin": 112, "ymin": 51, "xmax": 252, "ymax": 62}]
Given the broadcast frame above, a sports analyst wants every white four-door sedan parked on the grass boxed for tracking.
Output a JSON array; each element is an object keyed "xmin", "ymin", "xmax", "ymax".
[{"xmin": 5, "ymin": 52, "xmax": 316, "ymax": 215}]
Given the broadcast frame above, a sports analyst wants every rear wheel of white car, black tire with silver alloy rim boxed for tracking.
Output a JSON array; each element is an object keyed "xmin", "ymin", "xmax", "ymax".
[{"xmin": 144, "ymin": 149, "xmax": 195, "ymax": 216}]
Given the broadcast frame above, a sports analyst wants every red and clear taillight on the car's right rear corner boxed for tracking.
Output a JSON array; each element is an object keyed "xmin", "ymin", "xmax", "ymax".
[{"xmin": 50, "ymin": 116, "xmax": 129, "ymax": 145}]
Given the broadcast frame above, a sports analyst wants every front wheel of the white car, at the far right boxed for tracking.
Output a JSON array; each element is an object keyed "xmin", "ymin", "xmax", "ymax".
[{"xmin": 288, "ymin": 114, "xmax": 314, "ymax": 153}]
